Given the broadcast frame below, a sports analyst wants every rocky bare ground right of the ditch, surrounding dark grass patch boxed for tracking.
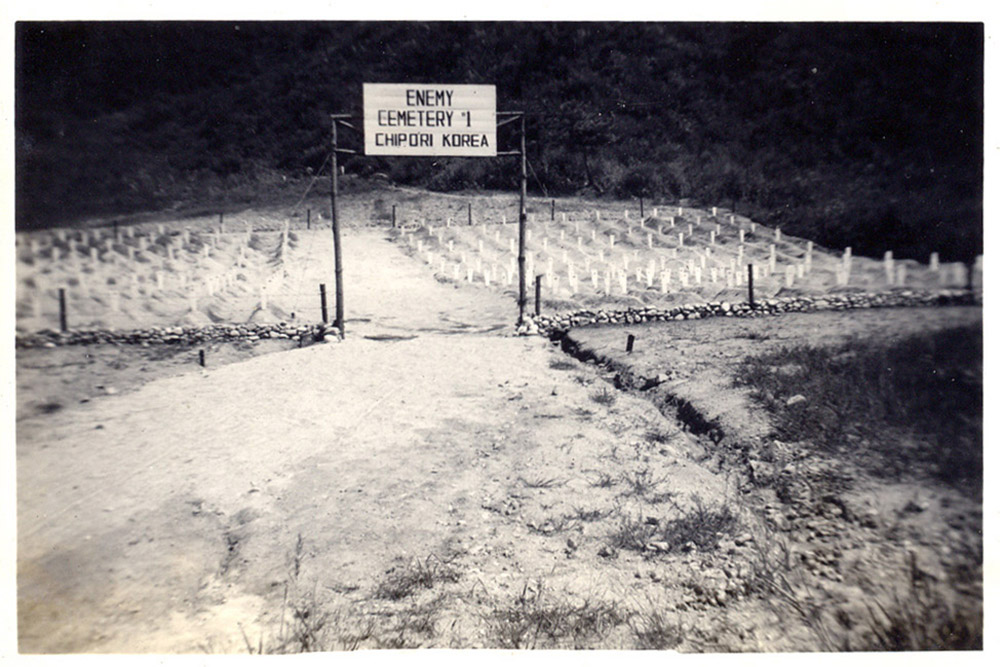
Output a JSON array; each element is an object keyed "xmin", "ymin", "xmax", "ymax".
[{"xmin": 566, "ymin": 307, "xmax": 983, "ymax": 648}]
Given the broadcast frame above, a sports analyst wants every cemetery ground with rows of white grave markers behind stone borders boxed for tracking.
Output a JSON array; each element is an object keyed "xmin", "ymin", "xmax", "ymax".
[{"xmin": 16, "ymin": 188, "xmax": 982, "ymax": 333}]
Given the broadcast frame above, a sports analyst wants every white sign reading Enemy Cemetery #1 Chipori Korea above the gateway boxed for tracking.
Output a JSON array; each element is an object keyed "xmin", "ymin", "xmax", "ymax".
[{"xmin": 363, "ymin": 83, "xmax": 497, "ymax": 157}]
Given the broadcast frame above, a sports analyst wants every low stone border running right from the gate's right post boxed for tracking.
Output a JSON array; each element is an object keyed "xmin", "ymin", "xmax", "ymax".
[{"xmin": 517, "ymin": 290, "xmax": 983, "ymax": 339}]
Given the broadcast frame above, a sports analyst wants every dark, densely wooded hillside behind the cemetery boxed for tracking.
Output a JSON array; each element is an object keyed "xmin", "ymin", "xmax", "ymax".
[{"xmin": 16, "ymin": 22, "xmax": 983, "ymax": 261}]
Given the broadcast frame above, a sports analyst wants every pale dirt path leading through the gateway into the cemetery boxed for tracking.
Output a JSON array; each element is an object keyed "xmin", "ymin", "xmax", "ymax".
[{"xmin": 17, "ymin": 232, "xmax": 712, "ymax": 652}]
